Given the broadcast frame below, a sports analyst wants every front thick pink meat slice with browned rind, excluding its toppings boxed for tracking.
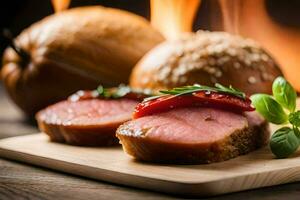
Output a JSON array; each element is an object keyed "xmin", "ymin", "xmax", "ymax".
[{"xmin": 117, "ymin": 107, "xmax": 269, "ymax": 164}]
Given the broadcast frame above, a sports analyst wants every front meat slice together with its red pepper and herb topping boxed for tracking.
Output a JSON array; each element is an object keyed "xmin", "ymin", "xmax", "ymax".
[{"xmin": 117, "ymin": 84, "xmax": 270, "ymax": 164}]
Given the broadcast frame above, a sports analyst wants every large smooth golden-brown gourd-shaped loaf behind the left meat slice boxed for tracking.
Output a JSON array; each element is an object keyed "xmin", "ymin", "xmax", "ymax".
[{"xmin": 1, "ymin": 6, "xmax": 163, "ymax": 116}]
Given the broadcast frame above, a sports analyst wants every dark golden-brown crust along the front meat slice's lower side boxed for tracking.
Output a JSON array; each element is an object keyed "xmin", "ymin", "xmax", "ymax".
[{"xmin": 117, "ymin": 114, "xmax": 270, "ymax": 164}]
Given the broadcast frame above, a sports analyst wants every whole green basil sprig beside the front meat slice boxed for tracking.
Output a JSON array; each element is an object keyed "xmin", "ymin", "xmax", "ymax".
[{"xmin": 251, "ymin": 77, "xmax": 300, "ymax": 158}]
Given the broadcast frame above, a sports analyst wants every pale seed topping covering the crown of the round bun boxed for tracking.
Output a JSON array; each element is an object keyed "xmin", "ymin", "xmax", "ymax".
[{"xmin": 151, "ymin": 31, "xmax": 272, "ymax": 85}]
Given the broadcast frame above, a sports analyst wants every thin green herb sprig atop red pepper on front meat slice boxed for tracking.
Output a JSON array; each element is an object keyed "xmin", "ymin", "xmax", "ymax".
[{"xmin": 144, "ymin": 83, "xmax": 246, "ymax": 101}]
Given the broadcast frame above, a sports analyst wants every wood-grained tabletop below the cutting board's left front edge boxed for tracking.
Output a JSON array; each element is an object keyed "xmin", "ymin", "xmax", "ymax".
[{"xmin": 0, "ymin": 160, "xmax": 178, "ymax": 200}]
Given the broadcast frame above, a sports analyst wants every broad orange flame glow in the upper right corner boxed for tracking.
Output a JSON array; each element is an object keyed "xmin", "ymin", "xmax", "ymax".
[{"xmin": 219, "ymin": 0, "xmax": 300, "ymax": 91}]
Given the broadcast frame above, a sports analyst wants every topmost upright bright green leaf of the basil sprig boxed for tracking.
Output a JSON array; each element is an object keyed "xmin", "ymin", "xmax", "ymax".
[{"xmin": 272, "ymin": 76, "xmax": 297, "ymax": 112}]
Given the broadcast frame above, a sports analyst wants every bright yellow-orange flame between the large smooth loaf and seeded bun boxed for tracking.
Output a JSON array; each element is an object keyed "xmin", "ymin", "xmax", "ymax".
[{"xmin": 150, "ymin": 0, "xmax": 201, "ymax": 39}]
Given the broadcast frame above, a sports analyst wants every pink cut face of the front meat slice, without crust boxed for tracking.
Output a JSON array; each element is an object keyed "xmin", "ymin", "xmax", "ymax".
[{"xmin": 119, "ymin": 108, "xmax": 248, "ymax": 144}]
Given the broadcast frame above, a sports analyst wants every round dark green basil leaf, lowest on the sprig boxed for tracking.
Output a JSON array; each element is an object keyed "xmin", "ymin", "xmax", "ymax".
[{"xmin": 270, "ymin": 127, "xmax": 299, "ymax": 158}]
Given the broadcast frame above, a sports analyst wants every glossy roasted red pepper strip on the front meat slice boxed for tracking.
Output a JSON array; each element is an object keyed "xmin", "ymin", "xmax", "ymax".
[{"xmin": 133, "ymin": 91, "xmax": 255, "ymax": 119}]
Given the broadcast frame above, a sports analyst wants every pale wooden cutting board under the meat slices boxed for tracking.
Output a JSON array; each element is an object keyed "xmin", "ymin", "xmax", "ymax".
[{"xmin": 0, "ymin": 127, "xmax": 300, "ymax": 196}]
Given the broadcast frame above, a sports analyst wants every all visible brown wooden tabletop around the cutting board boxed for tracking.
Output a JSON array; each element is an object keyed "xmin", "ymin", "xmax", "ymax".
[{"xmin": 0, "ymin": 84, "xmax": 300, "ymax": 200}]
